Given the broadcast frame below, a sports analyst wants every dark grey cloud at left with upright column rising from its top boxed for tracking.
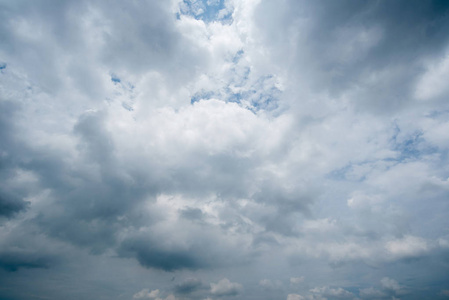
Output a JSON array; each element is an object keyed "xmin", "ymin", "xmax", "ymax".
[{"xmin": 30, "ymin": 112, "xmax": 157, "ymax": 253}]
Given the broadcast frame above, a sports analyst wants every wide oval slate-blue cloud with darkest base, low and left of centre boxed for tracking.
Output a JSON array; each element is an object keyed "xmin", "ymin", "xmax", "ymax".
[{"xmin": 117, "ymin": 223, "xmax": 252, "ymax": 271}]
